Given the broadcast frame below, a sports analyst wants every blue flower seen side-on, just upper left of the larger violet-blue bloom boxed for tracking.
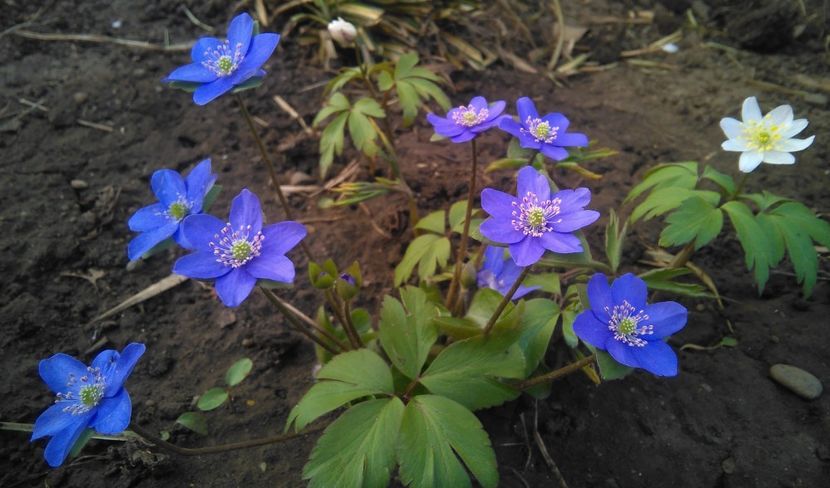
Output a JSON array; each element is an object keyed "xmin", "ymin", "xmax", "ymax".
[{"xmin": 127, "ymin": 159, "xmax": 216, "ymax": 261}]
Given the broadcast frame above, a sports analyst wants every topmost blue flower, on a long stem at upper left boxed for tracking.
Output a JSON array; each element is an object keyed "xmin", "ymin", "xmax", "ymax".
[{"xmin": 162, "ymin": 13, "xmax": 280, "ymax": 105}]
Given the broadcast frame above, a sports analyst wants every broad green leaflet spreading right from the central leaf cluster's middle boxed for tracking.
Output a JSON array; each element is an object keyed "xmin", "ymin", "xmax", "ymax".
[{"xmin": 421, "ymin": 334, "xmax": 525, "ymax": 410}]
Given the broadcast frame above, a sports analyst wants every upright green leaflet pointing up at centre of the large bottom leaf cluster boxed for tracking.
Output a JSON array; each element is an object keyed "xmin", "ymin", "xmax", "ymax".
[{"xmin": 378, "ymin": 286, "xmax": 438, "ymax": 379}]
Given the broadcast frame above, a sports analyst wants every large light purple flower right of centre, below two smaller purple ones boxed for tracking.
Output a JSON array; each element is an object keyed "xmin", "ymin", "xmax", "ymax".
[{"xmin": 481, "ymin": 166, "xmax": 599, "ymax": 267}]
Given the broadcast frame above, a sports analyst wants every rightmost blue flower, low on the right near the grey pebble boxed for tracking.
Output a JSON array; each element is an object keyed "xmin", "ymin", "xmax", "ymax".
[{"xmin": 574, "ymin": 273, "xmax": 688, "ymax": 376}]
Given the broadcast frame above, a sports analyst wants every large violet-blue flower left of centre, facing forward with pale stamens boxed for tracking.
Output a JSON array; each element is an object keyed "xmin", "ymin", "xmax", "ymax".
[{"xmin": 173, "ymin": 190, "xmax": 306, "ymax": 307}]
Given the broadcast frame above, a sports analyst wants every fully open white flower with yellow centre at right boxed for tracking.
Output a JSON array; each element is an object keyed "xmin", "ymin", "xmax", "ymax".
[{"xmin": 720, "ymin": 97, "xmax": 816, "ymax": 173}]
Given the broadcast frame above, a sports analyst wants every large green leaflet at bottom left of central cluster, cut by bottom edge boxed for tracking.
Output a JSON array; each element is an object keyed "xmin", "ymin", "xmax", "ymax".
[{"xmin": 303, "ymin": 397, "xmax": 404, "ymax": 488}]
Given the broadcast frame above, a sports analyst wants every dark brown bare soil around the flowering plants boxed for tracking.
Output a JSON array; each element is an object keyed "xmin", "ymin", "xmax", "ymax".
[{"xmin": 0, "ymin": 0, "xmax": 830, "ymax": 488}]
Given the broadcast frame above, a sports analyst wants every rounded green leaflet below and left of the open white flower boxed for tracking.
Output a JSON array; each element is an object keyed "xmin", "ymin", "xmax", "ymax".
[{"xmin": 660, "ymin": 196, "xmax": 723, "ymax": 251}]
